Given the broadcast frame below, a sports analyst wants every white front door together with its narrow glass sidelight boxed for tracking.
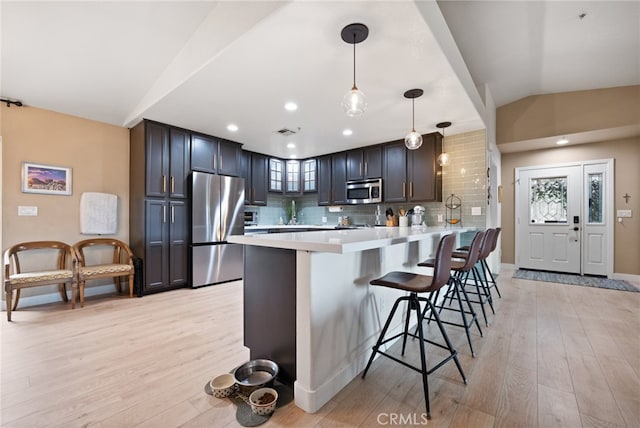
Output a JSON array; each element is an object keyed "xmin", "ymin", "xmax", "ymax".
[{"xmin": 516, "ymin": 160, "xmax": 613, "ymax": 276}]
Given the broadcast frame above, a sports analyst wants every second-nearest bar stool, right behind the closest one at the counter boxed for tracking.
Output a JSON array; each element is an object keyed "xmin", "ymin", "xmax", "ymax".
[{"xmin": 418, "ymin": 232, "xmax": 485, "ymax": 357}]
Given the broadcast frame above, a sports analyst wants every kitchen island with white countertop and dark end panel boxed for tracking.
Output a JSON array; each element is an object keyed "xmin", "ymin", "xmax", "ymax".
[{"xmin": 229, "ymin": 227, "xmax": 468, "ymax": 413}]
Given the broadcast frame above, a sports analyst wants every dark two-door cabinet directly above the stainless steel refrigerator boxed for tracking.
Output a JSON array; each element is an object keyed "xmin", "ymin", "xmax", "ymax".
[{"xmin": 191, "ymin": 133, "xmax": 242, "ymax": 177}]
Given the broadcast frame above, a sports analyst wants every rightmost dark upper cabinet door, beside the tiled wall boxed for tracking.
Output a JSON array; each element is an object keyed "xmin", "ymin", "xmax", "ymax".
[{"xmin": 407, "ymin": 134, "xmax": 442, "ymax": 202}]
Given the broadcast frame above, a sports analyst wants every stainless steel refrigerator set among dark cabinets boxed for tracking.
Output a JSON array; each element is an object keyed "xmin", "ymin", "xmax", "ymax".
[{"xmin": 191, "ymin": 172, "xmax": 244, "ymax": 287}]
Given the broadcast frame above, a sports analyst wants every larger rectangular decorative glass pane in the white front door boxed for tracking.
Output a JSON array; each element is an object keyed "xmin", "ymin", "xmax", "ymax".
[{"xmin": 529, "ymin": 176, "xmax": 567, "ymax": 224}]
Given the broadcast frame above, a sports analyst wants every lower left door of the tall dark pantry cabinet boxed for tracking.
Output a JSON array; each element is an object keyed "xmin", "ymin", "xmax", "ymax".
[{"xmin": 143, "ymin": 199, "xmax": 169, "ymax": 292}]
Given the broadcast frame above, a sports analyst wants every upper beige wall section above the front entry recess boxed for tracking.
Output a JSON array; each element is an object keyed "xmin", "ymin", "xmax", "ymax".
[{"xmin": 496, "ymin": 86, "xmax": 640, "ymax": 147}]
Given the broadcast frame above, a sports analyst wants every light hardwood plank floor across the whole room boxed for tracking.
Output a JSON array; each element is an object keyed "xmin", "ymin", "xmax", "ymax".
[{"xmin": 0, "ymin": 270, "xmax": 640, "ymax": 428}]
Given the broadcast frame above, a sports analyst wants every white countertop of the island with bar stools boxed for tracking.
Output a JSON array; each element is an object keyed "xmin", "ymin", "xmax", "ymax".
[{"xmin": 229, "ymin": 226, "xmax": 471, "ymax": 253}]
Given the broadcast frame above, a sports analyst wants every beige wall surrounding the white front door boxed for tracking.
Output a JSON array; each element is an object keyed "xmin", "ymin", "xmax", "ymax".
[{"xmin": 501, "ymin": 137, "xmax": 640, "ymax": 275}]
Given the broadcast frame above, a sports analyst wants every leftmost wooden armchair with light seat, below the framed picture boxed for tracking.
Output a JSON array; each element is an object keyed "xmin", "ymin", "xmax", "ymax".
[{"xmin": 4, "ymin": 241, "xmax": 78, "ymax": 321}]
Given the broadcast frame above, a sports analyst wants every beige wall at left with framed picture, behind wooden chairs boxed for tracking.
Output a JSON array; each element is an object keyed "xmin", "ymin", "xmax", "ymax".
[{"xmin": 0, "ymin": 105, "xmax": 129, "ymax": 299}]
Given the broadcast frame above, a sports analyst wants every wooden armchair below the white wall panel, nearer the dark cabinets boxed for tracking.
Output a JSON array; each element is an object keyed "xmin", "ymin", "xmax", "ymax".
[{"xmin": 73, "ymin": 238, "xmax": 134, "ymax": 306}]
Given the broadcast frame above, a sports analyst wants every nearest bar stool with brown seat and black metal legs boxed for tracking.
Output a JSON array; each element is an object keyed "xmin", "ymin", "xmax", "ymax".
[{"xmin": 362, "ymin": 234, "xmax": 467, "ymax": 419}]
